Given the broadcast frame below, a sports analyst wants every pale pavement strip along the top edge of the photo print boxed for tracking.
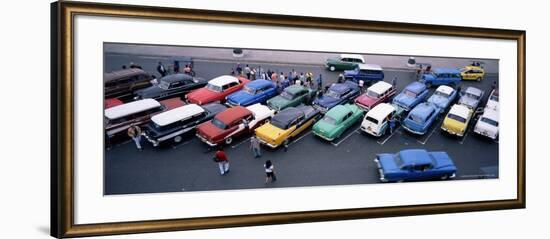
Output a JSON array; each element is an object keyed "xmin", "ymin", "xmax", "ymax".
[{"xmin": 105, "ymin": 43, "xmax": 498, "ymax": 73}]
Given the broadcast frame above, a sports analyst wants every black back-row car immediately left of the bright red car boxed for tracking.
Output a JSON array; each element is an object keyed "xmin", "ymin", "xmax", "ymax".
[{"xmin": 134, "ymin": 73, "xmax": 206, "ymax": 100}]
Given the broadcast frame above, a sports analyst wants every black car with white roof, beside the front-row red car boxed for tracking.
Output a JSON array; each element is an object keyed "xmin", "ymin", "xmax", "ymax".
[{"xmin": 143, "ymin": 103, "xmax": 227, "ymax": 147}]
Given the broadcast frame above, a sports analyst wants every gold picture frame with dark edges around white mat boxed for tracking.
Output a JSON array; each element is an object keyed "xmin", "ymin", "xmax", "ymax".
[{"xmin": 51, "ymin": 1, "xmax": 526, "ymax": 238}]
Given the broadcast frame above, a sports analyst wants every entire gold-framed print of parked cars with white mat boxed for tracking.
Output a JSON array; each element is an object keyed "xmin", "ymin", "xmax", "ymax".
[{"xmin": 51, "ymin": 2, "xmax": 525, "ymax": 237}]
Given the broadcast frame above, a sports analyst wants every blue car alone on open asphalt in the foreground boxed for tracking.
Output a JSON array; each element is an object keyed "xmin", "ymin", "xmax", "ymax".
[{"xmin": 374, "ymin": 149, "xmax": 456, "ymax": 182}]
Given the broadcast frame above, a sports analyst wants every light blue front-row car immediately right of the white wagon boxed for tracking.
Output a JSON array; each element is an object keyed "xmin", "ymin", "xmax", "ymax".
[{"xmin": 402, "ymin": 102, "xmax": 440, "ymax": 135}]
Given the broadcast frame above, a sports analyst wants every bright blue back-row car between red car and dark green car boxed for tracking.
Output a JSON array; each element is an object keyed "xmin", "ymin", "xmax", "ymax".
[{"xmin": 226, "ymin": 79, "xmax": 277, "ymax": 106}]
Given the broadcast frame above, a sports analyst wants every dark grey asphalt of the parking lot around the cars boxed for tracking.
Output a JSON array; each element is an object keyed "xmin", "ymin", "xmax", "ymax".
[{"xmin": 104, "ymin": 47, "xmax": 499, "ymax": 195}]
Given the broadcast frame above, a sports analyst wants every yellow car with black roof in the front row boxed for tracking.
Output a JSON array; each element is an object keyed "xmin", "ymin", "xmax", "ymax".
[{"xmin": 256, "ymin": 105, "xmax": 320, "ymax": 148}]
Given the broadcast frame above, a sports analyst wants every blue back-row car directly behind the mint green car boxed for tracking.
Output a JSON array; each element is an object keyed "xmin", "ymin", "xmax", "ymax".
[{"xmin": 313, "ymin": 81, "xmax": 361, "ymax": 114}]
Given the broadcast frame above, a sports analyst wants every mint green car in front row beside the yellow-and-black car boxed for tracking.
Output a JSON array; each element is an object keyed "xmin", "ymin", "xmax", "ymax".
[{"xmin": 313, "ymin": 104, "xmax": 363, "ymax": 141}]
